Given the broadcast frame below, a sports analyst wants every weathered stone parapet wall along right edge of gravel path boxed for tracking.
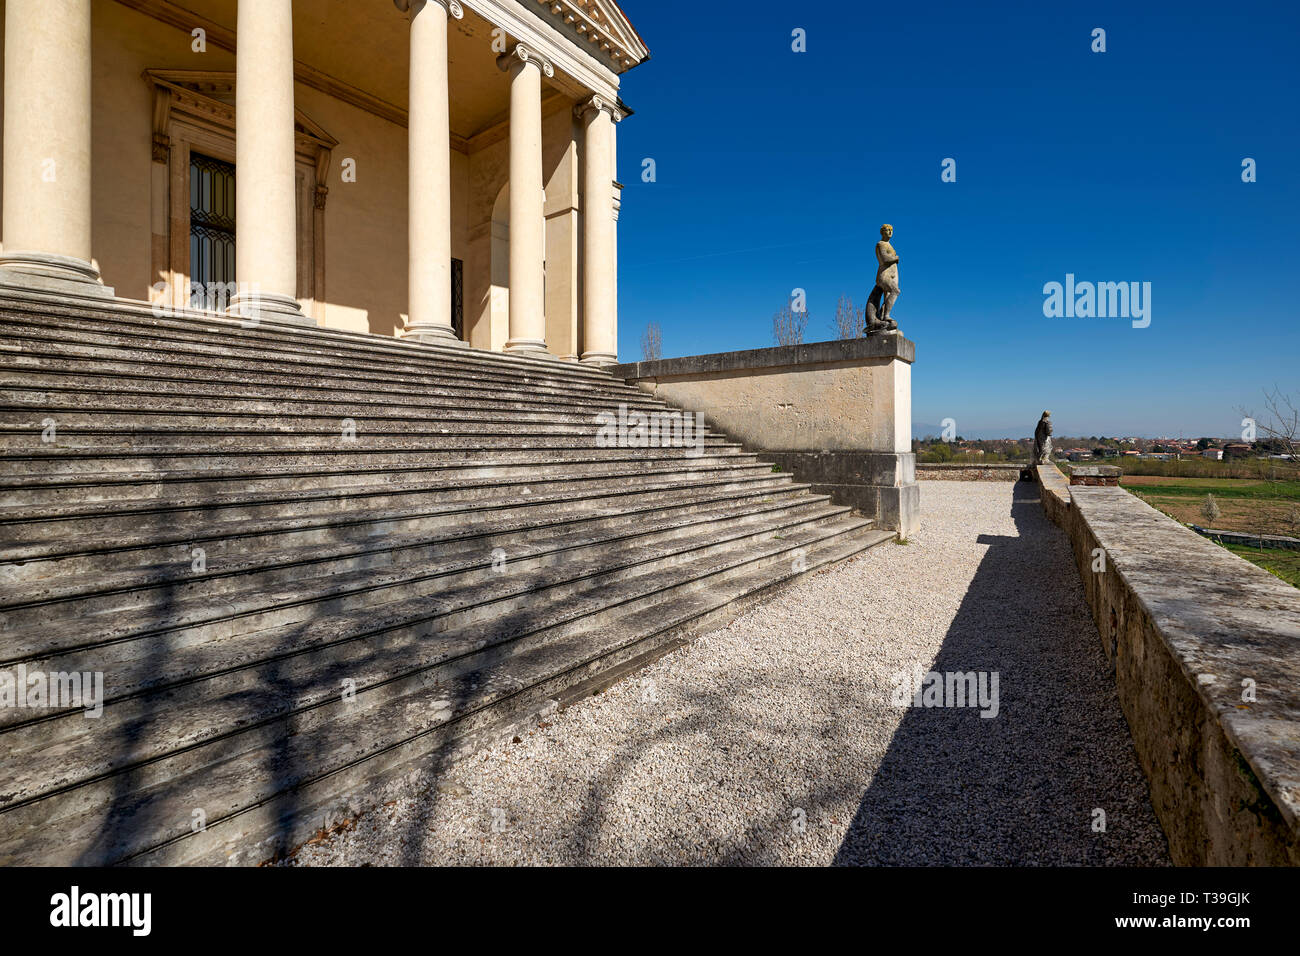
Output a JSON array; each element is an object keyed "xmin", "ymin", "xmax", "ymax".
[{"xmin": 1036, "ymin": 467, "xmax": 1300, "ymax": 866}]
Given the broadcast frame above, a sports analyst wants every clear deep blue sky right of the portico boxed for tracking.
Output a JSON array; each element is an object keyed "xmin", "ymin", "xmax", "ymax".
[{"xmin": 619, "ymin": 0, "xmax": 1300, "ymax": 437}]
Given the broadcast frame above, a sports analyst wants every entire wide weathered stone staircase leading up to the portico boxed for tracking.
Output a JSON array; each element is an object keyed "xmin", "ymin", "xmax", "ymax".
[{"xmin": 0, "ymin": 297, "xmax": 892, "ymax": 865}]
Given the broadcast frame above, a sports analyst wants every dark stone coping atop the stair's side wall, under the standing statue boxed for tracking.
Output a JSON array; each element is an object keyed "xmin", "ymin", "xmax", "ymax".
[{"xmin": 605, "ymin": 334, "xmax": 917, "ymax": 381}]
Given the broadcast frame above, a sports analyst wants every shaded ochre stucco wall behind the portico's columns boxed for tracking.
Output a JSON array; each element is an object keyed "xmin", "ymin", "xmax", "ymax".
[{"xmin": 0, "ymin": 0, "xmax": 581, "ymax": 355}]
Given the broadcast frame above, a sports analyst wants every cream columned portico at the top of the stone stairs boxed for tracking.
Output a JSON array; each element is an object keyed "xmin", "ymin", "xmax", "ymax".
[{"xmin": 0, "ymin": 0, "xmax": 649, "ymax": 364}]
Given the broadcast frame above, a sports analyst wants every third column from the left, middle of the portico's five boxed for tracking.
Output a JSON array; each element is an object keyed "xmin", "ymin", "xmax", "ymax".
[{"xmin": 405, "ymin": 0, "xmax": 464, "ymax": 345}]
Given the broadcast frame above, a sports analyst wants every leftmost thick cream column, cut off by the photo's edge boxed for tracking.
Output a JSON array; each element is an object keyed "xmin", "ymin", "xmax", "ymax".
[{"xmin": 0, "ymin": 0, "xmax": 113, "ymax": 297}]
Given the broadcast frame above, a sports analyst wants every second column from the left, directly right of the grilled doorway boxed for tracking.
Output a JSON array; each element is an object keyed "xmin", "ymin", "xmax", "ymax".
[{"xmin": 226, "ymin": 0, "xmax": 315, "ymax": 324}]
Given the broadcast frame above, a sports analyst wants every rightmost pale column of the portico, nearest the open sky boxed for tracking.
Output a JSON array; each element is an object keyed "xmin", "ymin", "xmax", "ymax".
[{"xmin": 575, "ymin": 96, "xmax": 620, "ymax": 365}]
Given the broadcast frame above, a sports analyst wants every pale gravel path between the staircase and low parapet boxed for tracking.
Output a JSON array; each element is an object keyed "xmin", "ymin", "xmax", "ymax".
[{"xmin": 286, "ymin": 481, "xmax": 1169, "ymax": 865}]
